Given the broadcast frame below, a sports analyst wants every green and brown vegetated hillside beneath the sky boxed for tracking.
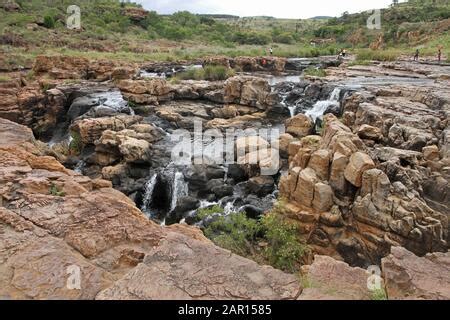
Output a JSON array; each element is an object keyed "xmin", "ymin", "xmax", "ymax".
[{"xmin": 0, "ymin": 0, "xmax": 450, "ymax": 66}]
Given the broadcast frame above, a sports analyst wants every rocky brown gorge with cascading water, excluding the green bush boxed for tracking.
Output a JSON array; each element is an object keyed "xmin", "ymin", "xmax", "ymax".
[{"xmin": 0, "ymin": 56, "xmax": 450, "ymax": 299}]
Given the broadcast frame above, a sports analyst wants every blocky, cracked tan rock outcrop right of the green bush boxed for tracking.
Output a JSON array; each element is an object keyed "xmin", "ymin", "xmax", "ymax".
[{"xmin": 280, "ymin": 115, "xmax": 448, "ymax": 266}]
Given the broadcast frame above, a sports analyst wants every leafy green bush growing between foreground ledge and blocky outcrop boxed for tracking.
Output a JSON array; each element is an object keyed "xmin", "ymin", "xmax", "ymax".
[{"xmin": 197, "ymin": 201, "xmax": 309, "ymax": 272}]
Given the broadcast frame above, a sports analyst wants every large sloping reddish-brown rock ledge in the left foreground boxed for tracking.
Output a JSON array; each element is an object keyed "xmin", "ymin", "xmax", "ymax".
[{"xmin": 0, "ymin": 119, "xmax": 301, "ymax": 300}]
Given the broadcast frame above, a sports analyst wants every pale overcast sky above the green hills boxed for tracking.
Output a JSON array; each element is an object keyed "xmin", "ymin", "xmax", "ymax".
[{"xmin": 134, "ymin": 0, "xmax": 400, "ymax": 19}]
